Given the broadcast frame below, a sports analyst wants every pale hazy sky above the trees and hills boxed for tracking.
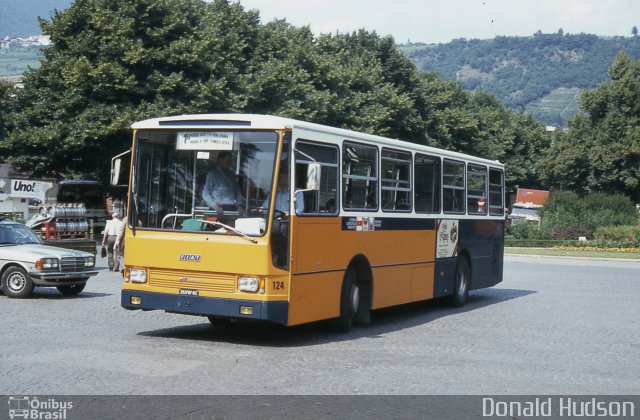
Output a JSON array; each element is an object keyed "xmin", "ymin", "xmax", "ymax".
[{"xmin": 239, "ymin": 0, "xmax": 640, "ymax": 44}]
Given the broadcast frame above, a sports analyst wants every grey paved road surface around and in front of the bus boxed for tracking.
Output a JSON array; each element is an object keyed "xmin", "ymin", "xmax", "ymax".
[{"xmin": 0, "ymin": 256, "xmax": 640, "ymax": 395}]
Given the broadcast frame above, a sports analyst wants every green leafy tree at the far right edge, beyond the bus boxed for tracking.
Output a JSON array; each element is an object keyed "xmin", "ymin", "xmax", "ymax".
[{"xmin": 541, "ymin": 52, "xmax": 640, "ymax": 201}]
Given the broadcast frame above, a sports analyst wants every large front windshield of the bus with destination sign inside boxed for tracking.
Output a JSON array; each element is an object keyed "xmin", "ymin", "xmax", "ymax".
[{"xmin": 130, "ymin": 130, "xmax": 278, "ymax": 236}]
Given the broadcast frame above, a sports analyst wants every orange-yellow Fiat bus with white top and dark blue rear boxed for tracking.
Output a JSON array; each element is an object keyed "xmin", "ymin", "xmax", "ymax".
[{"xmin": 117, "ymin": 114, "xmax": 505, "ymax": 331}]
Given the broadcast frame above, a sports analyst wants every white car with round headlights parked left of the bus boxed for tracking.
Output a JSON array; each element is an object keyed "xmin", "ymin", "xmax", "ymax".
[{"xmin": 0, "ymin": 220, "xmax": 98, "ymax": 298}]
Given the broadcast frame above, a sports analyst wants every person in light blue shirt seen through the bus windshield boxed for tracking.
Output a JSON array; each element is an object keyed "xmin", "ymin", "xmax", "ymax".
[{"xmin": 202, "ymin": 150, "xmax": 245, "ymax": 216}]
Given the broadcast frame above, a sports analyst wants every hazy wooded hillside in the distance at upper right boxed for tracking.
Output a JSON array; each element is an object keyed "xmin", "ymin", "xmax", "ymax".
[{"xmin": 400, "ymin": 31, "xmax": 640, "ymax": 126}]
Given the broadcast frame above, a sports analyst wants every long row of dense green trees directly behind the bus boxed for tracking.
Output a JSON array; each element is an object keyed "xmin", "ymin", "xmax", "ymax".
[{"xmin": 0, "ymin": 0, "xmax": 545, "ymax": 190}]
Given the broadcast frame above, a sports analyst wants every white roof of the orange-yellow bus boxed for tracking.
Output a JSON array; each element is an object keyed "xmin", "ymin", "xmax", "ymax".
[{"xmin": 131, "ymin": 114, "xmax": 503, "ymax": 167}]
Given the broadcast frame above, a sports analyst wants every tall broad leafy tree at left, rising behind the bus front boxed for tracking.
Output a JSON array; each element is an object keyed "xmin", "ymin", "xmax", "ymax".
[{"xmin": 1, "ymin": 0, "xmax": 258, "ymax": 177}]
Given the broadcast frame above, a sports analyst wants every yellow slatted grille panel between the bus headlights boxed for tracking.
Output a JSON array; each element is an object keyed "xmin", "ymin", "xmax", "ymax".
[{"xmin": 149, "ymin": 269, "xmax": 235, "ymax": 293}]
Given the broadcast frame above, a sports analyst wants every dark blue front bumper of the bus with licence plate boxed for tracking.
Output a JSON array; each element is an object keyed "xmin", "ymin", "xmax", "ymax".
[{"xmin": 120, "ymin": 290, "xmax": 289, "ymax": 325}]
